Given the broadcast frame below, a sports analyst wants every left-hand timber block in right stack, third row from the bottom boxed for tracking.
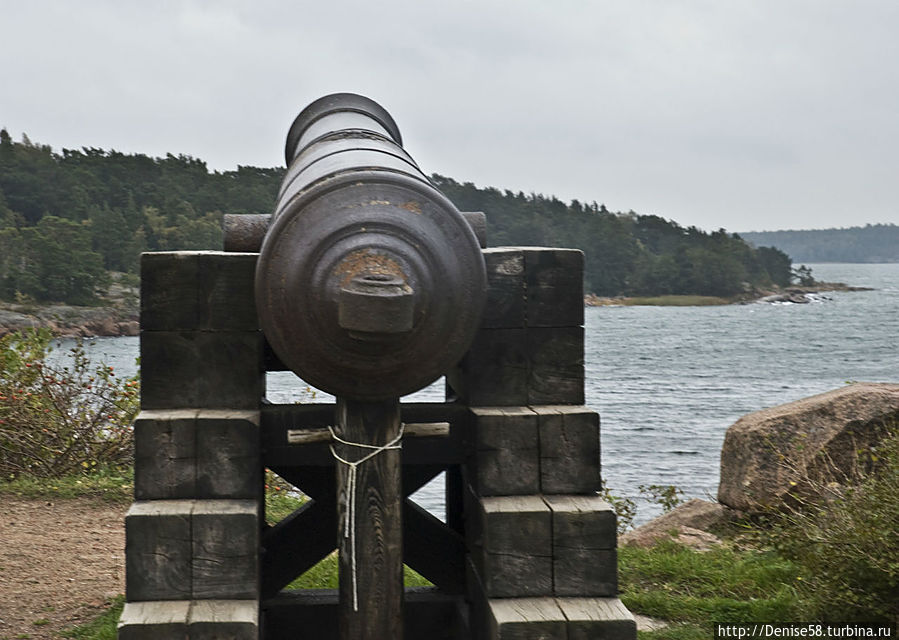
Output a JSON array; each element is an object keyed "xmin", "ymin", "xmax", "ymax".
[{"xmin": 466, "ymin": 407, "xmax": 540, "ymax": 496}]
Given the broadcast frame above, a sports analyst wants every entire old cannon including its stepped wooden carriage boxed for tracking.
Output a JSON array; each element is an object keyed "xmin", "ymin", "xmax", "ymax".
[{"xmin": 125, "ymin": 93, "xmax": 636, "ymax": 640}]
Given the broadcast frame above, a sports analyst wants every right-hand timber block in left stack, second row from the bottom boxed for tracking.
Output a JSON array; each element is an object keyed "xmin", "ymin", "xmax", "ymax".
[{"xmin": 191, "ymin": 500, "xmax": 260, "ymax": 599}]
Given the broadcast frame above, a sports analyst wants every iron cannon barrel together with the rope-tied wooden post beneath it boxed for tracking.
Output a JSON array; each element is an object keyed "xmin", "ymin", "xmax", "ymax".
[{"xmin": 255, "ymin": 93, "xmax": 486, "ymax": 639}]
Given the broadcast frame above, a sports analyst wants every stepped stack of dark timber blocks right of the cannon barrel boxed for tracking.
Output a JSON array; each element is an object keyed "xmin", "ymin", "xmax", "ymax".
[{"xmin": 447, "ymin": 247, "xmax": 636, "ymax": 640}]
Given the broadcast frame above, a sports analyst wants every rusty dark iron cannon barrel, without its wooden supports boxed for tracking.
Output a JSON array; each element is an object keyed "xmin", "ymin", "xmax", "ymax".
[{"xmin": 256, "ymin": 93, "xmax": 486, "ymax": 400}]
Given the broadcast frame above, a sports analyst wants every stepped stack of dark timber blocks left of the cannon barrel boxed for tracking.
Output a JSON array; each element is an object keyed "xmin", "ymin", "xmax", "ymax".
[{"xmin": 119, "ymin": 252, "xmax": 265, "ymax": 640}]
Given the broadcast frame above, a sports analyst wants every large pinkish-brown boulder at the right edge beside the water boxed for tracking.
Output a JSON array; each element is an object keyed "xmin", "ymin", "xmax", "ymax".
[{"xmin": 718, "ymin": 383, "xmax": 899, "ymax": 513}]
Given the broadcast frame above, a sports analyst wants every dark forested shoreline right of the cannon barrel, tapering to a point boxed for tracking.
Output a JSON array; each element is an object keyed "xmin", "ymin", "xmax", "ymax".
[{"xmin": 431, "ymin": 175, "xmax": 793, "ymax": 296}]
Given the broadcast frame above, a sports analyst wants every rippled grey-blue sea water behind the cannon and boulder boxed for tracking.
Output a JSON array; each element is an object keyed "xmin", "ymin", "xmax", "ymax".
[{"xmin": 75, "ymin": 264, "xmax": 899, "ymax": 521}]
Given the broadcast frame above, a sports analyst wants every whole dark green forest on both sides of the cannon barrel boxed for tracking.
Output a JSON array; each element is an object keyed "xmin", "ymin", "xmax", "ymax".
[{"xmin": 0, "ymin": 130, "xmax": 794, "ymax": 304}]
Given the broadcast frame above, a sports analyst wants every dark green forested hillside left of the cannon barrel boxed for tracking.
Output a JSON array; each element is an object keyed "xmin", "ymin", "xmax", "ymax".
[{"xmin": 0, "ymin": 129, "xmax": 284, "ymax": 304}]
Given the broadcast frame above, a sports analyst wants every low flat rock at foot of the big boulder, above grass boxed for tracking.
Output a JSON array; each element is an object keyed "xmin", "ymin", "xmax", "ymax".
[{"xmin": 618, "ymin": 498, "xmax": 736, "ymax": 551}]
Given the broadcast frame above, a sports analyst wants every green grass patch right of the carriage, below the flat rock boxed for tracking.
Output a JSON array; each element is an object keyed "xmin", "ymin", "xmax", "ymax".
[{"xmin": 618, "ymin": 541, "xmax": 801, "ymax": 624}]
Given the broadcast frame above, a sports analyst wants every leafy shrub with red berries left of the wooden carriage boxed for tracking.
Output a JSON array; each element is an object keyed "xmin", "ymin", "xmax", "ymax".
[{"xmin": 0, "ymin": 330, "xmax": 140, "ymax": 480}]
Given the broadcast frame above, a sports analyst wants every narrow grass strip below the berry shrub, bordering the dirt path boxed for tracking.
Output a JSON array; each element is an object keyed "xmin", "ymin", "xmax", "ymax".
[{"xmin": 0, "ymin": 467, "xmax": 134, "ymax": 503}]
